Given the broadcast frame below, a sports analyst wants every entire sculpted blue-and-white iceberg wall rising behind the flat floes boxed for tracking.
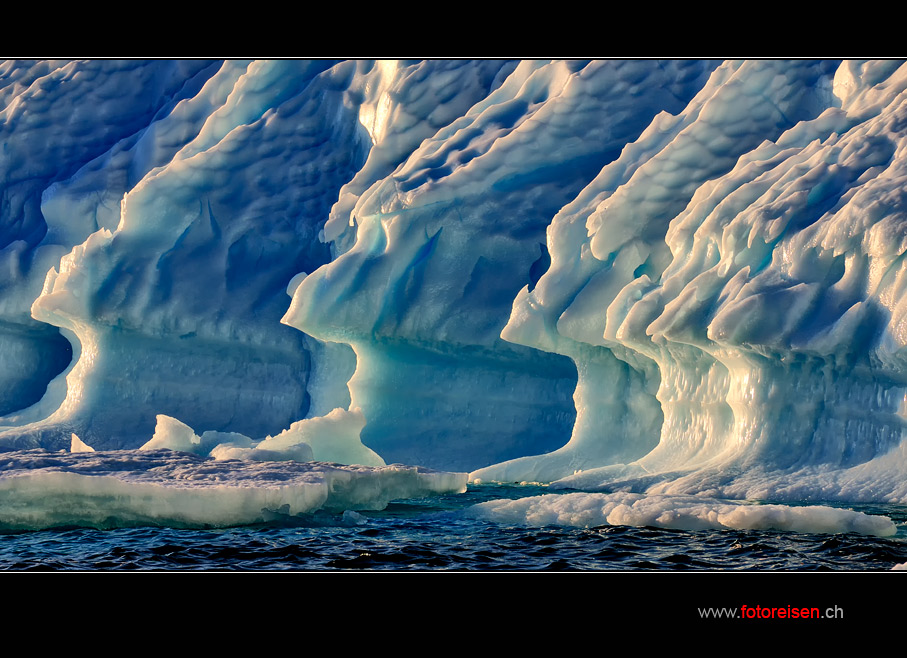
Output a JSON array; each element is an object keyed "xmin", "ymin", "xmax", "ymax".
[{"xmin": 0, "ymin": 60, "xmax": 907, "ymax": 502}]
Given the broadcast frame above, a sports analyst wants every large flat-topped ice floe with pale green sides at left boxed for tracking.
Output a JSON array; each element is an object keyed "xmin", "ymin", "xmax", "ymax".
[{"xmin": 0, "ymin": 450, "xmax": 466, "ymax": 530}]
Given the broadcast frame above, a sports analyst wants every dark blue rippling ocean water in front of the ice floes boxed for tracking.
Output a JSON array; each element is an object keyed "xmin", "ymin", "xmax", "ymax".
[{"xmin": 0, "ymin": 485, "xmax": 907, "ymax": 572}]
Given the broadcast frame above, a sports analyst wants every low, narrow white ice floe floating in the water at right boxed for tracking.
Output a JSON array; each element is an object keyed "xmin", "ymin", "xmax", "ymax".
[{"xmin": 464, "ymin": 493, "xmax": 897, "ymax": 537}]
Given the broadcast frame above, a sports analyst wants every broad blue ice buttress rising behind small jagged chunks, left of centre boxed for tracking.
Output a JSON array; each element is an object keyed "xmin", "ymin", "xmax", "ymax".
[{"xmin": 0, "ymin": 61, "xmax": 516, "ymax": 449}]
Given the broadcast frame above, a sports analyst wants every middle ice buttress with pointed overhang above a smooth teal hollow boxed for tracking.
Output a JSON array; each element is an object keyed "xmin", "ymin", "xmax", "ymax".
[{"xmin": 284, "ymin": 61, "xmax": 715, "ymax": 469}]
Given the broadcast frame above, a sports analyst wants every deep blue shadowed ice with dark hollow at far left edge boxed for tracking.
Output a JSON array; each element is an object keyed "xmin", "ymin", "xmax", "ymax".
[{"xmin": 0, "ymin": 60, "xmax": 216, "ymax": 415}]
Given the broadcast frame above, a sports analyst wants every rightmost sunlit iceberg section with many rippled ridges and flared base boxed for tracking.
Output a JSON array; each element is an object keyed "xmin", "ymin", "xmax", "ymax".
[{"xmin": 478, "ymin": 62, "xmax": 905, "ymax": 496}]
